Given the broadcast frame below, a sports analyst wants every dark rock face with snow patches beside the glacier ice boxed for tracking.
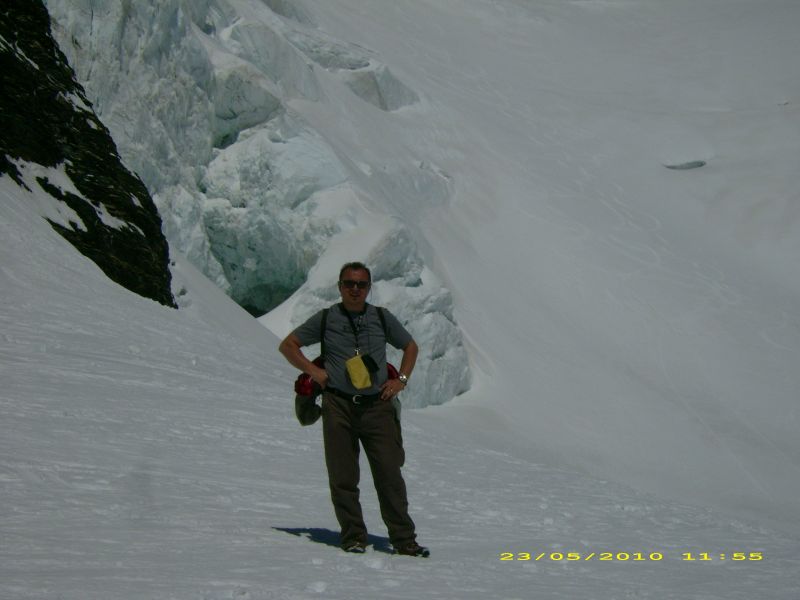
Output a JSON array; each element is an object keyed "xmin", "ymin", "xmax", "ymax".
[{"xmin": 0, "ymin": 0, "xmax": 176, "ymax": 307}]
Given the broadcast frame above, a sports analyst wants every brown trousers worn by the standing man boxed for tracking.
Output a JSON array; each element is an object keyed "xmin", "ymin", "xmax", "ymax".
[{"xmin": 322, "ymin": 393, "xmax": 416, "ymax": 547}]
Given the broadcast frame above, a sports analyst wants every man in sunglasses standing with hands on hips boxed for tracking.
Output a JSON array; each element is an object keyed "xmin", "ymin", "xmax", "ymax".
[{"xmin": 279, "ymin": 262, "xmax": 430, "ymax": 557}]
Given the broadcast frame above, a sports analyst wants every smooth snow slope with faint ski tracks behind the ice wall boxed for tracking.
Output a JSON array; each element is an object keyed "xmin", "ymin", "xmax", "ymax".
[{"xmin": 40, "ymin": 0, "xmax": 800, "ymax": 556}]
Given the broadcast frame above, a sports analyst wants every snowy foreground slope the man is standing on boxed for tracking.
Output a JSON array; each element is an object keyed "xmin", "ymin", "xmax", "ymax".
[{"xmin": 0, "ymin": 163, "xmax": 800, "ymax": 600}]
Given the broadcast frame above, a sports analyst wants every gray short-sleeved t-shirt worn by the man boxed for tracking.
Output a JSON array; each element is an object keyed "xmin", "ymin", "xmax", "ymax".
[{"xmin": 292, "ymin": 304, "xmax": 413, "ymax": 394}]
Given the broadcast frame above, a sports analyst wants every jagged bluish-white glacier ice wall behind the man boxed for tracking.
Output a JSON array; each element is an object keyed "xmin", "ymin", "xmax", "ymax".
[{"xmin": 47, "ymin": 0, "xmax": 470, "ymax": 406}]
